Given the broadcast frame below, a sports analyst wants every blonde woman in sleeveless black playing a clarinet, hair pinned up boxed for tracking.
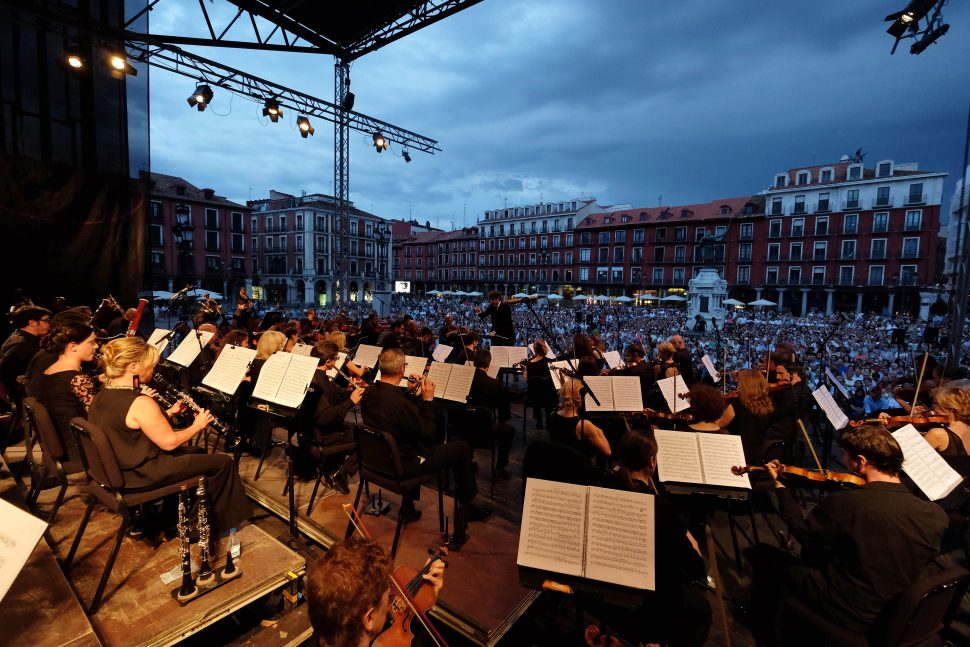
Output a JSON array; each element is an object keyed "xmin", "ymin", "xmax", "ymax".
[{"xmin": 88, "ymin": 337, "xmax": 250, "ymax": 538}]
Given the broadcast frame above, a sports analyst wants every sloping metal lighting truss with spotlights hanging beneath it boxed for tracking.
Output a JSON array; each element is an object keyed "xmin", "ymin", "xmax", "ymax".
[{"xmin": 125, "ymin": 38, "xmax": 441, "ymax": 155}]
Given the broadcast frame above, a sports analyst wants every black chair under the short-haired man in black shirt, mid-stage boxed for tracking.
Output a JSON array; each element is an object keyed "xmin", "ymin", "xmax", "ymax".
[{"xmin": 347, "ymin": 427, "xmax": 444, "ymax": 559}]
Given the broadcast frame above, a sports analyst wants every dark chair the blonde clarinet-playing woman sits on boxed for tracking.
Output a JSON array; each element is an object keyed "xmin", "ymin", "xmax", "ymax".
[{"xmin": 64, "ymin": 418, "xmax": 199, "ymax": 614}]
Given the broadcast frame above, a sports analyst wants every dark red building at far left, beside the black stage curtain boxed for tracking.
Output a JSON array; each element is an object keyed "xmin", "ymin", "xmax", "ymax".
[{"xmin": 148, "ymin": 173, "xmax": 253, "ymax": 296}]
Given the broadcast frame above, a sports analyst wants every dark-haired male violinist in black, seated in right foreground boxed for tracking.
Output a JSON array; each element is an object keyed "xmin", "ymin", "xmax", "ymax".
[{"xmin": 752, "ymin": 425, "xmax": 948, "ymax": 645}]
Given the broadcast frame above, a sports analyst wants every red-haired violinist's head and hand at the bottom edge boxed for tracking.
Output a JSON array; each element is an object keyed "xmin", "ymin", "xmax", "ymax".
[{"xmin": 304, "ymin": 538, "xmax": 445, "ymax": 647}]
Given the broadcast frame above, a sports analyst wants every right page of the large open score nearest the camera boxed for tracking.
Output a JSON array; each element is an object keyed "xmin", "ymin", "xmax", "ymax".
[{"xmin": 586, "ymin": 487, "xmax": 656, "ymax": 591}]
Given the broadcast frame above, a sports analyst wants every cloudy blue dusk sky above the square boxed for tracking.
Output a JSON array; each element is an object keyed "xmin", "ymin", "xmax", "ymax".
[{"xmin": 144, "ymin": 0, "xmax": 970, "ymax": 228}]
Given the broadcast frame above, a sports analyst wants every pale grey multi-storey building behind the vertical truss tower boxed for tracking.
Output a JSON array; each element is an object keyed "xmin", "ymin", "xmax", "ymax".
[{"xmin": 248, "ymin": 191, "xmax": 392, "ymax": 306}]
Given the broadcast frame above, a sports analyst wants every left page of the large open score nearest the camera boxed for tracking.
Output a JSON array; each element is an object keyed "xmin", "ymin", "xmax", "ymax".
[{"xmin": 516, "ymin": 478, "xmax": 586, "ymax": 577}]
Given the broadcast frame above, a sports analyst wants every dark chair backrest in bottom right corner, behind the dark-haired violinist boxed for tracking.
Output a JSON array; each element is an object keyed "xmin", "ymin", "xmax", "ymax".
[{"xmin": 877, "ymin": 566, "xmax": 970, "ymax": 645}]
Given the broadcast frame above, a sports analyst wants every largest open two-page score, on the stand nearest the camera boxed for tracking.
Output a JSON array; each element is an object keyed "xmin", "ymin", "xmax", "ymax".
[{"xmin": 517, "ymin": 478, "xmax": 656, "ymax": 591}]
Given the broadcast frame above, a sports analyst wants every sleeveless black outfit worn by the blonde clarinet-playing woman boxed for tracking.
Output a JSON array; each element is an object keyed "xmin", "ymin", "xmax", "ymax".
[{"xmin": 88, "ymin": 388, "xmax": 250, "ymax": 536}]
